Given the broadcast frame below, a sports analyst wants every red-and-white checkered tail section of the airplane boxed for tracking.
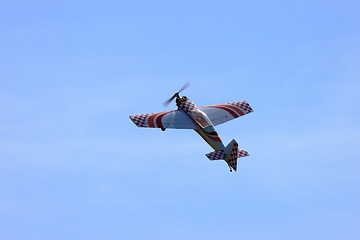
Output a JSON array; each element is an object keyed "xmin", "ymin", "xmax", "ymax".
[{"xmin": 206, "ymin": 139, "xmax": 249, "ymax": 171}]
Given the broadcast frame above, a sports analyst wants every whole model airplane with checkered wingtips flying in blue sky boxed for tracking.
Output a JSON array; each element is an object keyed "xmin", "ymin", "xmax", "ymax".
[{"xmin": 130, "ymin": 84, "xmax": 253, "ymax": 172}]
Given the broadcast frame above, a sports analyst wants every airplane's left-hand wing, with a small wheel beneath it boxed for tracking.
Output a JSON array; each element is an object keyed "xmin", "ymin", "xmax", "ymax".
[{"xmin": 130, "ymin": 110, "xmax": 198, "ymax": 129}]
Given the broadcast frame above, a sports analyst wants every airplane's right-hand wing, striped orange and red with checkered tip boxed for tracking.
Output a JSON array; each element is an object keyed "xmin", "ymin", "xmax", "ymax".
[{"xmin": 199, "ymin": 101, "xmax": 253, "ymax": 126}]
